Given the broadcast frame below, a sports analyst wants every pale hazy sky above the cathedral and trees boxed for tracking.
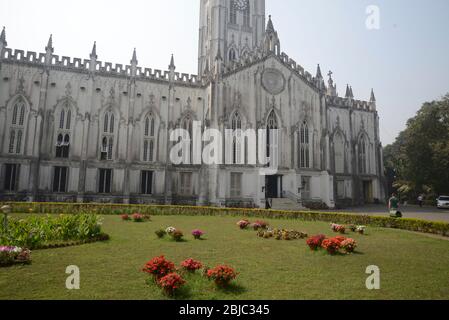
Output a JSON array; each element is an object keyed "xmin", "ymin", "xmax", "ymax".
[{"xmin": 0, "ymin": 0, "xmax": 449, "ymax": 144}]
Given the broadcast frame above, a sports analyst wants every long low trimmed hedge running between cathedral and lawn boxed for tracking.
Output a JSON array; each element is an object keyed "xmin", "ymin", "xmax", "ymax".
[{"xmin": 0, "ymin": 202, "xmax": 449, "ymax": 237}]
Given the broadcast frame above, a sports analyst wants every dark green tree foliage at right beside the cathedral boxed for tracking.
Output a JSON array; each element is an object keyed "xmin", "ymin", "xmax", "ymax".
[{"xmin": 384, "ymin": 94, "xmax": 449, "ymax": 199}]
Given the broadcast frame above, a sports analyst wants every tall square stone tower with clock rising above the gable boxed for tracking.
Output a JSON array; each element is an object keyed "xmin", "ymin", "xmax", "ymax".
[{"xmin": 198, "ymin": 0, "xmax": 265, "ymax": 75}]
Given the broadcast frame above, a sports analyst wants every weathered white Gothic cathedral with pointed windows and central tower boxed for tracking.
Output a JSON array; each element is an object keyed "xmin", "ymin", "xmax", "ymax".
[{"xmin": 0, "ymin": 0, "xmax": 386, "ymax": 208}]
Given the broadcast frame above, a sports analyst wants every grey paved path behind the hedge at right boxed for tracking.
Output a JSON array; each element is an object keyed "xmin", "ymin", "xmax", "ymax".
[{"xmin": 324, "ymin": 205, "xmax": 449, "ymax": 222}]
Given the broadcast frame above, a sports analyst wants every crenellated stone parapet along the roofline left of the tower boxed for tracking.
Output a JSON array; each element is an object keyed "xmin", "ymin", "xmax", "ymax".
[{"xmin": 1, "ymin": 48, "xmax": 203, "ymax": 87}]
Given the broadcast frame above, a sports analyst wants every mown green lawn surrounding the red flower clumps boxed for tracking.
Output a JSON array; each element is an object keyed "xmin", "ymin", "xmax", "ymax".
[{"xmin": 0, "ymin": 216, "xmax": 449, "ymax": 300}]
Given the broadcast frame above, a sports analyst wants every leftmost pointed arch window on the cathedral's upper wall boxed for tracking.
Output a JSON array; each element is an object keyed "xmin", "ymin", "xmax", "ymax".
[{"xmin": 8, "ymin": 98, "xmax": 26, "ymax": 154}]
